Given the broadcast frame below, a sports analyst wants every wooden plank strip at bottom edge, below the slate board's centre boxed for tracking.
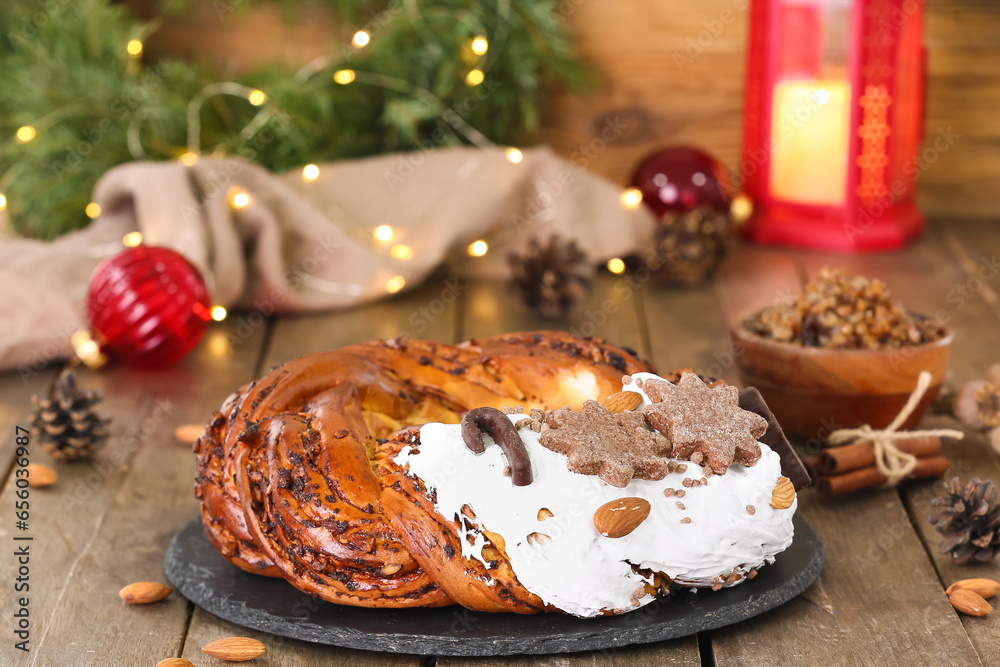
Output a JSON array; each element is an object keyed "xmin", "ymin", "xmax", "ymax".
[{"xmin": 437, "ymin": 636, "xmax": 701, "ymax": 667}]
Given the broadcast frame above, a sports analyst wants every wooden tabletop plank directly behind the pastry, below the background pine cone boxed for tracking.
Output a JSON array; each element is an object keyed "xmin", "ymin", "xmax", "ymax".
[{"xmin": 461, "ymin": 273, "xmax": 649, "ymax": 355}]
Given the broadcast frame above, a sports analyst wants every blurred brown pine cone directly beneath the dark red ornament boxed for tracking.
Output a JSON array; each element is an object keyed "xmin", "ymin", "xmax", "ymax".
[{"xmin": 653, "ymin": 207, "xmax": 731, "ymax": 285}]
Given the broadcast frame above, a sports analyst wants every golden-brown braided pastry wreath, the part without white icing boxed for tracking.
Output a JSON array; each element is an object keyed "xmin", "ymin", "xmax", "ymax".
[{"xmin": 194, "ymin": 332, "xmax": 790, "ymax": 614}]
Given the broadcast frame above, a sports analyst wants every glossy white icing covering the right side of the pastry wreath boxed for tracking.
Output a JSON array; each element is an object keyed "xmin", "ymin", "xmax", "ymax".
[{"xmin": 395, "ymin": 373, "xmax": 798, "ymax": 617}]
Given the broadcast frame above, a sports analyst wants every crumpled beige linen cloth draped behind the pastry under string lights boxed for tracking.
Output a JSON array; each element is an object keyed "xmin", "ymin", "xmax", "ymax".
[{"xmin": 0, "ymin": 147, "xmax": 653, "ymax": 373}]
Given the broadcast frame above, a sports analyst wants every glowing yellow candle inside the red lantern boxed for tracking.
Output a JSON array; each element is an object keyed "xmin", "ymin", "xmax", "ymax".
[{"xmin": 771, "ymin": 79, "xmax": 851, "ymax": 206}]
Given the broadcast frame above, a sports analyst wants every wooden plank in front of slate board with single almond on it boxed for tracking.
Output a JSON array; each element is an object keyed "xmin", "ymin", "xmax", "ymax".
[{"xmin": 181, "ymin": 612, "xmax": 421, "ymax": 667}]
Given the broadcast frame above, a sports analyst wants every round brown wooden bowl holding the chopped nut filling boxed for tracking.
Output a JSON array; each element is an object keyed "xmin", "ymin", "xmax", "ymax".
[{"xmin": 732, "ymin": 313, "xmax": 954, "ymax": 444}]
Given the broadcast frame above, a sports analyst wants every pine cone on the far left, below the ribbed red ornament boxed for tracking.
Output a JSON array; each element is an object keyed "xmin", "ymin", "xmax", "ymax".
[{"xmin": 31, "ymin": 370, "xmax": 110, "ymax": 462}]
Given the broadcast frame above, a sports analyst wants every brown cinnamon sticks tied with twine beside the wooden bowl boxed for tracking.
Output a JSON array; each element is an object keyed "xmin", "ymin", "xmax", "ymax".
[{"xmin": 805, "ymin": 437, "xmax": 948, "ymax": 496}]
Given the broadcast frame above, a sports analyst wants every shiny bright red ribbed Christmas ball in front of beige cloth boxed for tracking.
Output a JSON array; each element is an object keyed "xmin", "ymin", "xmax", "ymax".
[{"xmin": 87, "ymin": 245, "xmax": 211, "ymax": 368}]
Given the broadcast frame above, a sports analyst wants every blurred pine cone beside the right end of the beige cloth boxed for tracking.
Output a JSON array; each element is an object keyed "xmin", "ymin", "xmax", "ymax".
[{"xmin": 507, "ymin": 236, "xmax": 593, "ymax": 320}]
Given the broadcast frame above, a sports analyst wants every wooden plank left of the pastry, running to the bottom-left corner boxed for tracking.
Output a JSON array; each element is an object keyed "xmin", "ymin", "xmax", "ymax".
[{"xmin": 0, "ymin": 323, "xmax": 263, "ymax": 667}]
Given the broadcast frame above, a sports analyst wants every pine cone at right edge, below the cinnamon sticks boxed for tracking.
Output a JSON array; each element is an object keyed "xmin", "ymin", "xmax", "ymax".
[{"xmin": 930, "ymin": 477, "xmax": 1000, "ymax": 565}]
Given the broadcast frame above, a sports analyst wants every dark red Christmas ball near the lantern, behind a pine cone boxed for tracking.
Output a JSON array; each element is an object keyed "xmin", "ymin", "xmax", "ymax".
[{"xmin": 631, "ymin": 146, "xmax": 731, "ymax": 217}]
